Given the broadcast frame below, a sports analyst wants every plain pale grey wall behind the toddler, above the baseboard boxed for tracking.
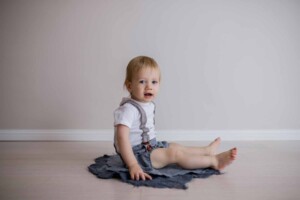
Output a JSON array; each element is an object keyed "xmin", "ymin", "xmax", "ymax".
[{"xmin": 0, "ymin": 0, "xmax": 300, "ymax": 130}]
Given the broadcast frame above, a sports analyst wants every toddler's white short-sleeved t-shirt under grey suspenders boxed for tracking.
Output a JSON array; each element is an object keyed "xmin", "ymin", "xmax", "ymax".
[{"xmin": 114, "ymin": 97, "xmax": 156, "ymax": 148}]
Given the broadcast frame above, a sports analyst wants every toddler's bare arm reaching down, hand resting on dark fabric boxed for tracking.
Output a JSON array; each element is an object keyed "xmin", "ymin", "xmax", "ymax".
[{"xmin": 117, "ymin": 124, "xmax": 152, "ymax": 180}]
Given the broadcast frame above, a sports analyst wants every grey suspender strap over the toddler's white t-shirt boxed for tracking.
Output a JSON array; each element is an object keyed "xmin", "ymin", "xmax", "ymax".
[{"xmin": 120, "ymin": 98, "xmax": 155, "ymax": 144}]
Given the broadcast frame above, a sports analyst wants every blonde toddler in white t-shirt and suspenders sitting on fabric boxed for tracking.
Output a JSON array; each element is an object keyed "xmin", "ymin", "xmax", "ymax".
[{"xmin": 114, "ymin": 56, "xmax": 237, "ymax": 180}]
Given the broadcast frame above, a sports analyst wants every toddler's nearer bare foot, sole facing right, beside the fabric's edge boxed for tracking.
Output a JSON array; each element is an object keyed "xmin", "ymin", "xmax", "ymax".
[{"xmin": 213, "ymin": 148, "xmax": 237, "ymax": 170}]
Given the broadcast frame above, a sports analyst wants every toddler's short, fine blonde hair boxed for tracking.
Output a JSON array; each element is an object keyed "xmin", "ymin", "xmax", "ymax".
[{"xmin": 124, "ymin": 56, "xmax": 160, "ymax": 88}]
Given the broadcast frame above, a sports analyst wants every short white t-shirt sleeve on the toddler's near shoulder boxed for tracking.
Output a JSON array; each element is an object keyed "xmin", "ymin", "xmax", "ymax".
[{"xmin": 114, "ymin": 104, "xmax": 136, "ymax": 128}]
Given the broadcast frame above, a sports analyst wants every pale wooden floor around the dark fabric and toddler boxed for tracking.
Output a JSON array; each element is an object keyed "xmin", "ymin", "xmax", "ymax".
[{"xmin": 0, "ymin": 141, "xmax": 300, "ymax": 200}]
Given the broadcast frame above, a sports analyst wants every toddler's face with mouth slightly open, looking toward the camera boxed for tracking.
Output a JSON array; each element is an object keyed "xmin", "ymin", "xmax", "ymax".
[{"xmin": 127, "ymin": 67, "xmax": 160, "ymax": 102}]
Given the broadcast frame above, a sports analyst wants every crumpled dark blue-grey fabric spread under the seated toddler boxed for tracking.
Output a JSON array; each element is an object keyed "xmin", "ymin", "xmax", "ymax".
[{"xmin": 88, "ymin": 154, "xmax": 220, "ymax": 189}]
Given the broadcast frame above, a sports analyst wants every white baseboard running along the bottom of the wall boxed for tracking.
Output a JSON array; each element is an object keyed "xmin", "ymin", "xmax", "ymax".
[{"xmin": 0, "ymin": 129, "xmax": 300, "ymax": 141}]
